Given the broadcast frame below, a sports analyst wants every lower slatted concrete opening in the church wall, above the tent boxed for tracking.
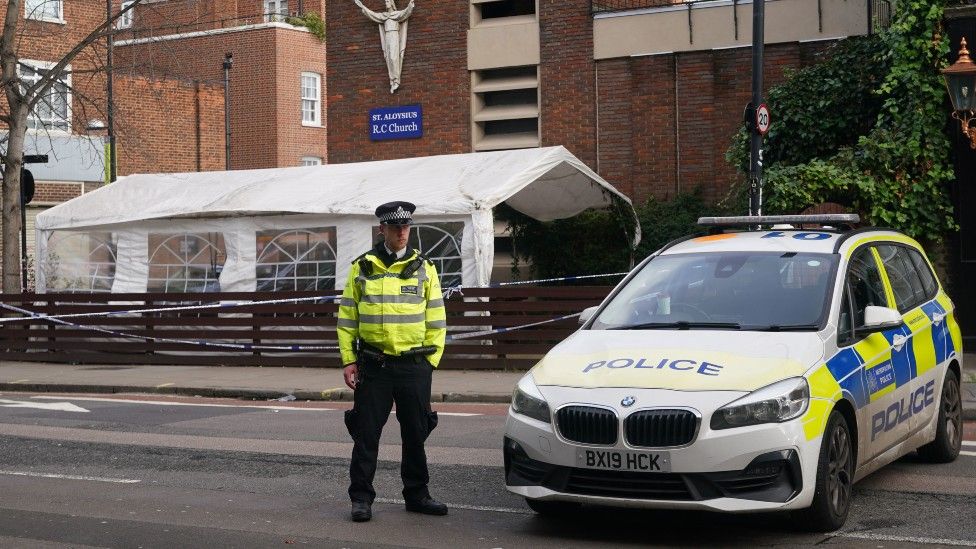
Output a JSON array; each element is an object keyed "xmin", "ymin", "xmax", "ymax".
[{"xmin": 471, "ymin": 66, "xmax": 540, "ymax": 151}]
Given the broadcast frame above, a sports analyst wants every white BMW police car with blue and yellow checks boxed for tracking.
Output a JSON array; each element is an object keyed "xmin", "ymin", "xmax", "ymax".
[{"xmin": 504, "ymin": 215, "xmax": 963, "ymax": 531}]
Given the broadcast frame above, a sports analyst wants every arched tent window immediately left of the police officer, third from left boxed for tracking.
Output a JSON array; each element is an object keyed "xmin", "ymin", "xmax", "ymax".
[{"xmin": 255, "ymin": 227, "xmax": 336, "ymax": 291}]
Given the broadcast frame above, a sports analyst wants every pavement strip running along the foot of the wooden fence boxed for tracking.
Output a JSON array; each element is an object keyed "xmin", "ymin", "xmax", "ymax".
[{"xmin": 0, "ymin": 353, "xmax": 976, "ymax": 420}]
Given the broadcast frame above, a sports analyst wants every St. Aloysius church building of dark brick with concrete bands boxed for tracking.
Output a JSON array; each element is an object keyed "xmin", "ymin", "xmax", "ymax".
[{"xmin": 326, "ymin": 0, "xmax": 869, "ymax": 201}]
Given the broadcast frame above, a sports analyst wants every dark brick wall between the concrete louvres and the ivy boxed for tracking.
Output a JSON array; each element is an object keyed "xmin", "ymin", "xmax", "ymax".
[{"xmin": 596, "ymin": 42, "xmax": 829, "ymax": 202}]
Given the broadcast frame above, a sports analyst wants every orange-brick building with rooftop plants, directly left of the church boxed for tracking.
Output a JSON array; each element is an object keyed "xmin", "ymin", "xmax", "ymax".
[{"xmin": 115, "ymin": 0, "xmax": 328, "ymax": 169}]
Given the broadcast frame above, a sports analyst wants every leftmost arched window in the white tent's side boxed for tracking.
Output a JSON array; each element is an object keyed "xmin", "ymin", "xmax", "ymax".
[{"xmin": 40, "ymin": 231, "xmax": 117, "ymax": 293}]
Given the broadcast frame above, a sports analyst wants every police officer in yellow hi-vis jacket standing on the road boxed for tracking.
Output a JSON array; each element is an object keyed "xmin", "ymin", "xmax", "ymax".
[{"xmin": 337, "ymin": 202, "xmax": 447, "ymax": 522}]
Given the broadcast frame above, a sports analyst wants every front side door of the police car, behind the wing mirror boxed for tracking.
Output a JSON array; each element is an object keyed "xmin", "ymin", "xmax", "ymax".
[{"xmin": 828, "ymin": 245, "xmax": 908, "ymax": 463}]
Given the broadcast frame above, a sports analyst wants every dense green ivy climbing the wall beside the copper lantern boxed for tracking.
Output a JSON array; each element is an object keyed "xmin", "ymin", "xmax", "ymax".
[{"xmin": 727, "ymin": 0, "xmax": 957, "ymax": 241}]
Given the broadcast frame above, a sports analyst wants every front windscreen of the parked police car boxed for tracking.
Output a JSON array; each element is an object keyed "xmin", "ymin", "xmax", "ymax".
[{"xmin": 590, "ymin": 252, "xmax": 838, "ymax": 331}]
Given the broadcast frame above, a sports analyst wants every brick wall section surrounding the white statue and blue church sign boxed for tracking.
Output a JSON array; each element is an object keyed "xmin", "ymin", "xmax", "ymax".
[{"xmin": 326, "ymin": 0, "xmax": 471, "ymax": 163}]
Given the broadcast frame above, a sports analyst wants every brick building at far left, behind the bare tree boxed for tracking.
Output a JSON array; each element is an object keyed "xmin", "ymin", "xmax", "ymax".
[{"xmin": 0, "ymin": 0, "xmax": 224, "ymax": 282}]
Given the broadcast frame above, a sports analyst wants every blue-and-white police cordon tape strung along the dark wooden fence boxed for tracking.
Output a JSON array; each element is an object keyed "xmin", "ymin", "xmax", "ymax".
[{"xmin": 0, "ymin": 273, "xmax": 627, "ymax": 351}]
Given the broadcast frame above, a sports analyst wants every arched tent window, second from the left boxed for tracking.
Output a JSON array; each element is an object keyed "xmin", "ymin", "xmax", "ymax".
[{"xmin": 147, "ymin": 233, "xmax": 227, "ymax": 293}]
